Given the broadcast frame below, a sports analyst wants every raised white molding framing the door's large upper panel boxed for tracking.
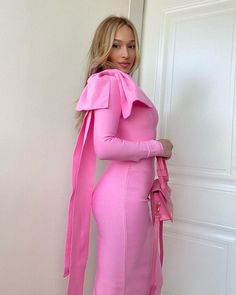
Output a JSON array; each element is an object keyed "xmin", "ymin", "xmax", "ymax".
[{"xmin": 158, "ymin": 4, "xmax": 236, "ymax": 180}]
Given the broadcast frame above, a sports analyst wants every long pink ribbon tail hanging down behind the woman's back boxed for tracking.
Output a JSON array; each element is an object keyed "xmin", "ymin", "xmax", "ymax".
[{"xmin": 64, "ymin": 111, "xmax": 96, "ymax": 295}]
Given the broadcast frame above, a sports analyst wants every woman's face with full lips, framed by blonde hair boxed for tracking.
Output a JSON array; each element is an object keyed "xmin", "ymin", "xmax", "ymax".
[{"xmin": 108, "ymin": 25, "xmax": 136, "ymax": 74}]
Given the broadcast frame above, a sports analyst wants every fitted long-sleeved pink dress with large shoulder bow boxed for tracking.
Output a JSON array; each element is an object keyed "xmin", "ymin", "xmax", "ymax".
[{"xmin": 65, "ymin": 69, "xmax": 163, "ymax": 295}]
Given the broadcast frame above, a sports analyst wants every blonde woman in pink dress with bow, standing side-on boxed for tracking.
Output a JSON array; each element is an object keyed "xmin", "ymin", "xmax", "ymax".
[{"xmin": 64, "ymin": 16, "xmax": 173, "ymax": 295}]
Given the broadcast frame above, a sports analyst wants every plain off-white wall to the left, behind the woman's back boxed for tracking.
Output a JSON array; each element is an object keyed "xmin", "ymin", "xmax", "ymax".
[{"xmin": 0, "ymin": 0, "xmax": 129, "ymax": 295}]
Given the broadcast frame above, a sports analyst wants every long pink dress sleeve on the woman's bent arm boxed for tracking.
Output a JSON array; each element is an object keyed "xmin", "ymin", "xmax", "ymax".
[{"xmin": 94, "ymin": 78, "xmax": 163, "ymax": 162}]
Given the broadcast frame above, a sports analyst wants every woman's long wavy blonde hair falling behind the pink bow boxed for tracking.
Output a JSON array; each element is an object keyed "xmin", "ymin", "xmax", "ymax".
[{"xmin": 76, "ymin": 15, "xmax": 140, "ymax": 129}]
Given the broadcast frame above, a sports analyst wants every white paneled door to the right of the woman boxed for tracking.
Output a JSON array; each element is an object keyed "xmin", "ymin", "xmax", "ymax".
[{"xmin": 140, "ymin": 0, "xmax": 236, "ymax": 295}]
